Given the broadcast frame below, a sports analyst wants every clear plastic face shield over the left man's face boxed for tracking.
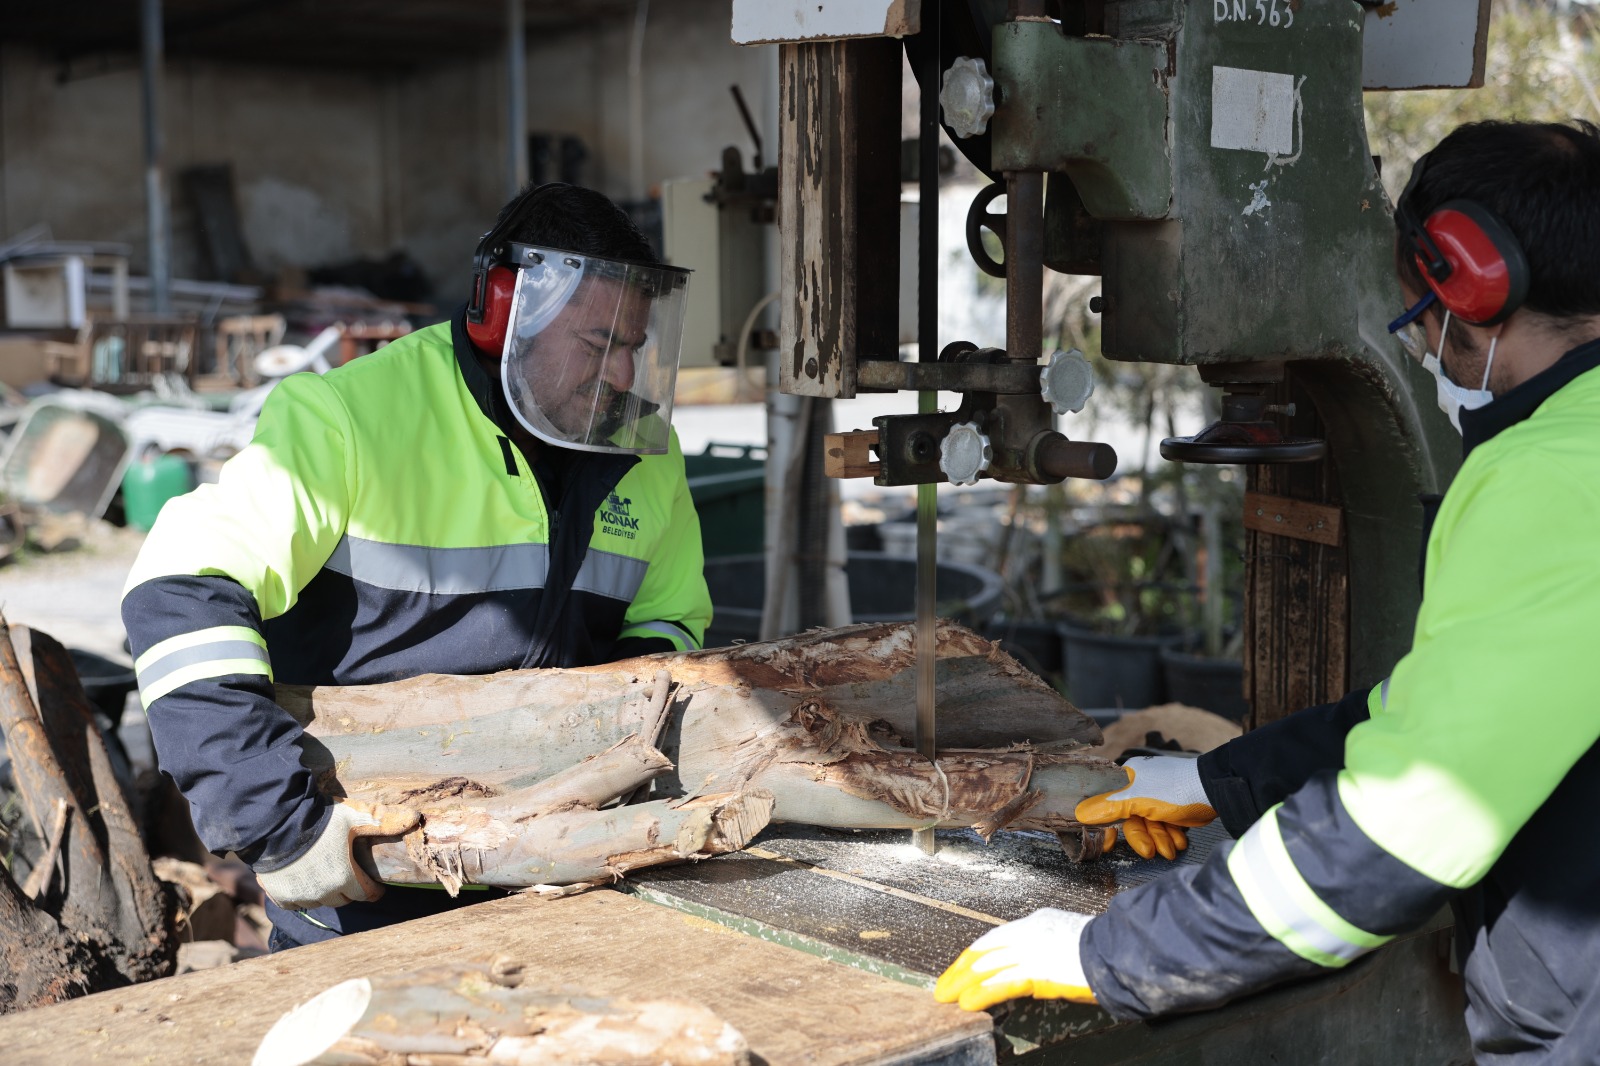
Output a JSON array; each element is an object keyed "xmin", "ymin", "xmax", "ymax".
[{"xmin": 501, "ymin": 245, "xmax": 688, "ymax": 455}]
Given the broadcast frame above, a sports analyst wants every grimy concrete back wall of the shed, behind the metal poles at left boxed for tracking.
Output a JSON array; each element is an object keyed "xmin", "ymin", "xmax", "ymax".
[{"xmin": 0, "ymin": 48, "xmax": 395, "ymax": 277}]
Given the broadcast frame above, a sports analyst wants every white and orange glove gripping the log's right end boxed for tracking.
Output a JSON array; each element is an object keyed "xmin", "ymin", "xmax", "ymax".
[{"xmin": 1074, "ymin": 755, "xmax": 1216, "ymax": 860}]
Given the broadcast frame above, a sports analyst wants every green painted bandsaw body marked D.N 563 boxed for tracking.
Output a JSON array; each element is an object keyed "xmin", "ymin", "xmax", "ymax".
[{"xmin": 990, "ymin": 0, "xmax": 1461, "ymax": 687}]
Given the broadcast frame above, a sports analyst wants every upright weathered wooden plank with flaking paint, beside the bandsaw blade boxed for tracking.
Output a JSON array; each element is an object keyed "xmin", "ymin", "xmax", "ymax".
[{"xmin": 778, "ymin": 37, "xmax": 904, "ymax": 397}]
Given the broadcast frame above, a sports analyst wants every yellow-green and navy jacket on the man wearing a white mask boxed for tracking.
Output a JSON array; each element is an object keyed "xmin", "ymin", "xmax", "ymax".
[{"xmin": 1082, "ymin": 341, "xmax": 1600, "ymax": 1066}]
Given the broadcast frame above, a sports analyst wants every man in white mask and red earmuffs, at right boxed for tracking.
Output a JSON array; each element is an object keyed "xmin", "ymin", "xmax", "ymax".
[{"xmin": 936, "ymin": 122, "xmax": 1600, "ymax": 1066}]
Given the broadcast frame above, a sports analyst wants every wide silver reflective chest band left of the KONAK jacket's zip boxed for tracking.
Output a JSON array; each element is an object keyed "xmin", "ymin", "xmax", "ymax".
[{"xmin": 323, "ymin": 535, "xmax": 550, "ymax": 595}]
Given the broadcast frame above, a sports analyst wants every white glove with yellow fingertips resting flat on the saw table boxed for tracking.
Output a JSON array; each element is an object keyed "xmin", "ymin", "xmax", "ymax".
[{"xmin": 933, "ymin": 908, "xmax": 1094, "ymax": 1010}]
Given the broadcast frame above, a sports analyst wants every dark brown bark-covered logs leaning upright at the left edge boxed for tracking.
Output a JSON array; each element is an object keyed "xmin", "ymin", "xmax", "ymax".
[{"xmin": 0, "ymin": 619, "xmax": 178, "ymax": 1013}]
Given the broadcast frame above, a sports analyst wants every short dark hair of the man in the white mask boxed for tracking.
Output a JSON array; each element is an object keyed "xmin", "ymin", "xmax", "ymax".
[{"xmin": 1397, "ymin": 118, "xmax": 1600, "ymax": 319}]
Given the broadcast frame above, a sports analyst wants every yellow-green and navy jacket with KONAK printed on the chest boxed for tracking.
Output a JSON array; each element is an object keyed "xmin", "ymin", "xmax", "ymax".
[{"xmin": 123, "ymin": 320, "xmax": 710, "ymax": 895}]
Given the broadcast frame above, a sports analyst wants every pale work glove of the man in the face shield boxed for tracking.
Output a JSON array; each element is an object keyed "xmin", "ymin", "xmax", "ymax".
[{"xmin": 256, "ymin": 802, "xmax": 422, "ymax": 911}]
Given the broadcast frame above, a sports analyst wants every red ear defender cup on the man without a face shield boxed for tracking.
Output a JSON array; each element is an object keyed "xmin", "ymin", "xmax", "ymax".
[{"xmin": 1413, "ymin": 200, "xmax": 1528, "ymax": 327}]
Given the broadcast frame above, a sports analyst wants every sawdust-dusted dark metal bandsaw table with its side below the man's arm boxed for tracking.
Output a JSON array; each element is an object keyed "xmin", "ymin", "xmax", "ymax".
[{"xmin": 618, "ymin": 824, "xmax": 1469, "ymax": 1066}]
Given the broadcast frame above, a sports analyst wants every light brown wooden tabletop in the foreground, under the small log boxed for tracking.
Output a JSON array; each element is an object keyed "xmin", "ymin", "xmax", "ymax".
[{"xmin": 0, "ymin": 890, "xmax": 992, "ymax": 1066}]
